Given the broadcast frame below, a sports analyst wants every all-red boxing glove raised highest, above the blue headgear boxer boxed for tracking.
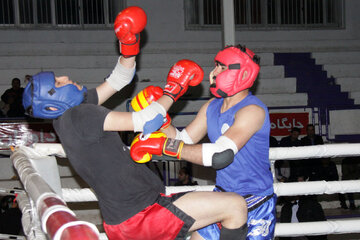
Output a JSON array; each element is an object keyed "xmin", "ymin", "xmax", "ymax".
[{"xmin": 114, "ymin": 6, "xmax": 147, "ymax": 57}]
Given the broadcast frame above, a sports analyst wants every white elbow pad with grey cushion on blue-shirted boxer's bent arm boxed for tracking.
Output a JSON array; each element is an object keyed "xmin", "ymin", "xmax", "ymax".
[{"xmin": 202, "ymin": 136, "xmax": 238, "ymax": 170}]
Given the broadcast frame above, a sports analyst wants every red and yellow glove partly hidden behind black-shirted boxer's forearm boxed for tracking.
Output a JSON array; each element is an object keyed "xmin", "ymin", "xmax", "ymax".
[{"xmin": 130, "ymin": 85, "xmax": 171, "ymax": 129}]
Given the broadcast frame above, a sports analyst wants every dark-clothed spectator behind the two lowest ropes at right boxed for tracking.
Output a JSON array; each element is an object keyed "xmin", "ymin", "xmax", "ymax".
[{"xmin": 279, "ymin": 177, "xmax": 327, "ymax": 240}]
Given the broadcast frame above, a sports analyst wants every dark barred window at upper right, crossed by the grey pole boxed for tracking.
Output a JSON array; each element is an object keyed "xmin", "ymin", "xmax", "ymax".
[{"xmin": 185, "ymin": 0, "xmax": 344, "ymax": 29}]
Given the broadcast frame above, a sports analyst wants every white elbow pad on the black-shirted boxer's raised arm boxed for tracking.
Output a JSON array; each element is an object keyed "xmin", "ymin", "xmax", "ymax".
[{"xmin": 106, "ymin": 57, "xmax": 136, "ymax": 91}]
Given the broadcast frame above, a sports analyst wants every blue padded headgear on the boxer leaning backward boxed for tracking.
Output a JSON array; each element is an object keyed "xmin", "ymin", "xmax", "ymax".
[{"xmin": 23, "ymin": 72, "xmax": 87, "ymax": 119}]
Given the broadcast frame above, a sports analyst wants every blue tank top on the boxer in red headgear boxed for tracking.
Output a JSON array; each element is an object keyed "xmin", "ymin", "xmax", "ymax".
[{"xmin": 206, "ymin": 92, "xmax": 274, "ymax": 196}]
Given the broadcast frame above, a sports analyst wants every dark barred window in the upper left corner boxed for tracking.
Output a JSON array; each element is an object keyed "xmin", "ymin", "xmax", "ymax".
[{"xmin": 0, "ymin": 0, "xmax": 125, "ymax": 28}]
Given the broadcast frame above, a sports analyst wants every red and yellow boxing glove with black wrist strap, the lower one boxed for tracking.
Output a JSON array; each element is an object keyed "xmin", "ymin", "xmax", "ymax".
[{"xmin": 130, "ymin": 132, "xmax": 184, "ymax": 163}]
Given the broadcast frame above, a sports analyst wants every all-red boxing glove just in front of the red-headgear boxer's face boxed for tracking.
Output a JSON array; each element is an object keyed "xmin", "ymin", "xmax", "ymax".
[{"xmin": 164, "ymin": 59, "xmax": 204, "ymax": 102}]
